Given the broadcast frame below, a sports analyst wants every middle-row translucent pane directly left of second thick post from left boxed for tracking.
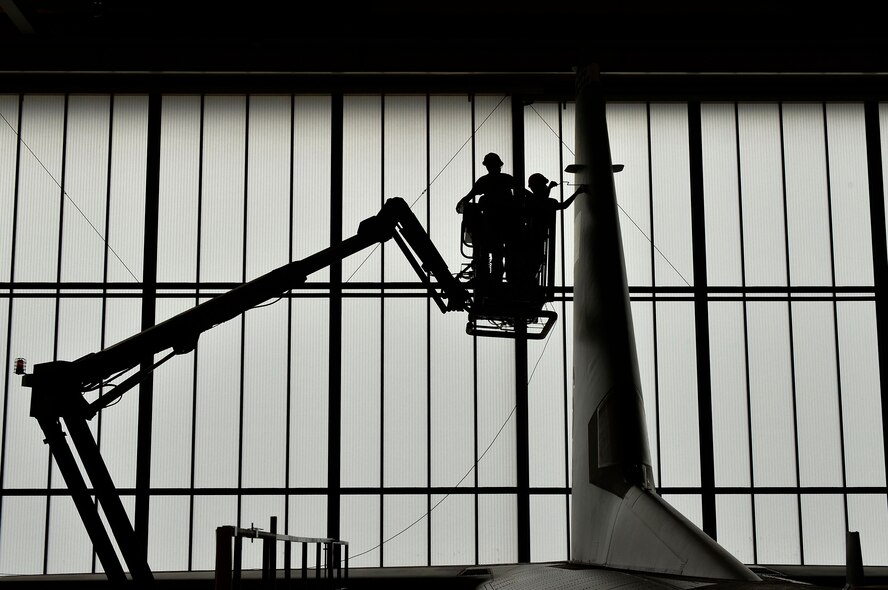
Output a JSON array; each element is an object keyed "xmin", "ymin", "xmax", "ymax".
[{"xmin": 288, "ymin": 299, "xmax": 330, "ymax": 490}]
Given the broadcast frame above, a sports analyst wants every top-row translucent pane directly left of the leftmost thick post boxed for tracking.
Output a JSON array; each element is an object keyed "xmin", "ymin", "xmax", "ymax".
[{"xmin": 105, "ymin": 96, "xmax": 147, "ymax": 282}]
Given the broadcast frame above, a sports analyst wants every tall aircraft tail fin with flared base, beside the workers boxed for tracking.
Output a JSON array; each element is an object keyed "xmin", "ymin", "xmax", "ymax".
[{"xmin": 571, "ymin": 67, "xmax": 759, "ymax": 581}]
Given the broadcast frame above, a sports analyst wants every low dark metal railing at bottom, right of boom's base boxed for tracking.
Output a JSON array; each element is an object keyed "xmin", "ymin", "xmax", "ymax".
[{"xmin": 216, "ymin": 516, "xmax": 348, "ymax": 590}]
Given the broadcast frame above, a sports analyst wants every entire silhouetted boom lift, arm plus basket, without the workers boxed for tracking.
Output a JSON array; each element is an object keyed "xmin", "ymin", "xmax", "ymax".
[{"xmin": 15, "ymin": 198, "xmax": 555, "ymax": 586}]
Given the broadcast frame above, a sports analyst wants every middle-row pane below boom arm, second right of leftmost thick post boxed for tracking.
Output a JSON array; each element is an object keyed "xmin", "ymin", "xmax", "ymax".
[{"xmin": 191, "ymin": 317, "xmax": 239, "ymax": 487}]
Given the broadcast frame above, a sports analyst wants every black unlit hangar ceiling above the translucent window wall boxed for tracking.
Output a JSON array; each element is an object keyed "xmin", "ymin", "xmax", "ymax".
[{"xmin": 0, "ymin": 0, "xmax": 888, "ymax": 97}]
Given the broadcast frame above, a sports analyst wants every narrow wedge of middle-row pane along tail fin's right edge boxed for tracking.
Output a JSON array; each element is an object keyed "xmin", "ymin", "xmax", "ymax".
[{"xmin": 632, "ymin": 301, "xmax": 660, "ymax": 482}]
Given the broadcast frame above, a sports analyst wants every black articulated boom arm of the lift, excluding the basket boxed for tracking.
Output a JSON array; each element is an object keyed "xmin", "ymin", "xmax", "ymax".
[{"xmin": 22, "ymin": 198, "xmax": 471, "ymax": 584}]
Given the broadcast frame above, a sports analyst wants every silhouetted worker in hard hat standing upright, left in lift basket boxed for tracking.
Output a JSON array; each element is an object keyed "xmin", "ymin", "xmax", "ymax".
[{"xmin": 456, "ymin": 152, "xmax": 523, "ymax": 281}]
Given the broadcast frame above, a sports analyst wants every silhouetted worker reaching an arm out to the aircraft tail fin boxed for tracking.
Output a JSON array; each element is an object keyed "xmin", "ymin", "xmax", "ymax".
[{"xmin": 509, "ymin": 173, "xmax": 586, "ymax": 285}]
